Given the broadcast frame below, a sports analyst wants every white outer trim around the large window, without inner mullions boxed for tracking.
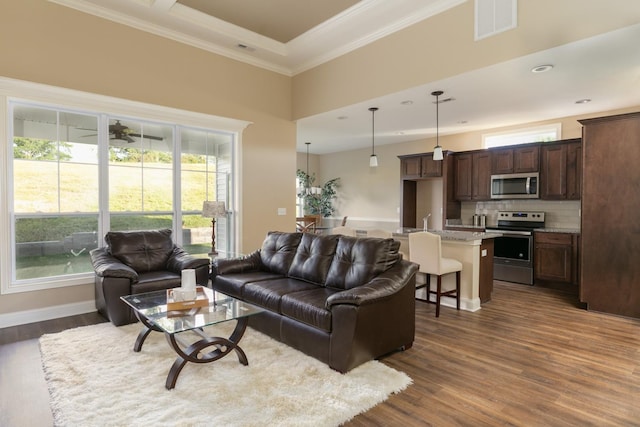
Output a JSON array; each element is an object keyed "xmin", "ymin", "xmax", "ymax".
[{"xmin": 0, "ymin": 77, "xmax": 251, "ymax": 294}]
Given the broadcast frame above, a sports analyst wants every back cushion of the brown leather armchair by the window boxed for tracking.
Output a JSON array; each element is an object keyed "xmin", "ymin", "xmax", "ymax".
[{"xmin": 104, "ymin": 229, "xmax": 174, "ymax": 273}]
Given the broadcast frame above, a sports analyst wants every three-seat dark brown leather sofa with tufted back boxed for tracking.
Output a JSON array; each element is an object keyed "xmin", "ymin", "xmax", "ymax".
[{"xmin": 211, "ymin": 232, "xmax": 418, "ymax": 372}]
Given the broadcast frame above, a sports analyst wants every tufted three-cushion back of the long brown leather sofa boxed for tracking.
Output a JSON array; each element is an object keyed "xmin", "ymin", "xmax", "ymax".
[{"xmin": 260, "ymin": 232, "xmax": 401, "ymax": 289}]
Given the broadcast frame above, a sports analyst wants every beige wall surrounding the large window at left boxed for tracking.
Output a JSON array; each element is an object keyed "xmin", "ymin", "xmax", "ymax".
[{"xmin": 0, "ymin": 0, "xmax": 296, "ymax": 314}]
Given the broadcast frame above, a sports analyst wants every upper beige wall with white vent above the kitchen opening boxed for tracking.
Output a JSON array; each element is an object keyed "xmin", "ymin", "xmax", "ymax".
[{"xmin": 293, "ymin": 0, "xmax": 640, "ymax": 119}]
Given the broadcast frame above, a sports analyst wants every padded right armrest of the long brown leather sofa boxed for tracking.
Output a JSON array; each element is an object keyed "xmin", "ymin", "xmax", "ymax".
[{"xmin": 326, "ymin": 260, "xmax": 418, "ymax": 310}]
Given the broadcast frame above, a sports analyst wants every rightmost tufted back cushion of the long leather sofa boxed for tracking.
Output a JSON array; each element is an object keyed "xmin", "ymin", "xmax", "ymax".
[{"xmin": 325, "ymin": 236, "xmax": 400, "ymax": 289}]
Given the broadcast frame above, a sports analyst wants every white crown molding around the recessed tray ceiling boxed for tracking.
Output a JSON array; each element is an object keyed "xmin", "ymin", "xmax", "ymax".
[{"xmin": 49, "ymin": 0, "xmax": 468, "ymax": 76}]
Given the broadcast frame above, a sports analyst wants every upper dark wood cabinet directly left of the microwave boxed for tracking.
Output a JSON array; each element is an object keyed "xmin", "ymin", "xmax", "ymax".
[{"xmin": 454, "ymin": 150, "xmax": 491, "ymax": 200}]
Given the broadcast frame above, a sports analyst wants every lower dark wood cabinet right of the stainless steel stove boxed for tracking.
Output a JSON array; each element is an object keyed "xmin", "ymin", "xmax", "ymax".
[{"xmin": 534, "ymin": 232, "xmax": 579, "ymax": 285}]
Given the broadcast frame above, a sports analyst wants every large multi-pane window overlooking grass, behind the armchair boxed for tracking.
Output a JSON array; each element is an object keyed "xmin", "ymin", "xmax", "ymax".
[{"xmin": 3, "ymin": 101, "xmax": 236, "ymax": 292}]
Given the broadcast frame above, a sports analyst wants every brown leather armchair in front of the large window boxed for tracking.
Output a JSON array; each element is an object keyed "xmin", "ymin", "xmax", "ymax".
[{"xmin": 90, "ymin": 229, "xmax": 209, "ymax": 326}]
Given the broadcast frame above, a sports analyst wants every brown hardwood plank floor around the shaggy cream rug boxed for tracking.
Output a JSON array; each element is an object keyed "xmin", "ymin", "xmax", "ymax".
[{"xmin": 0, "ymin": 281, "xmax": 640, "ymax": 427}]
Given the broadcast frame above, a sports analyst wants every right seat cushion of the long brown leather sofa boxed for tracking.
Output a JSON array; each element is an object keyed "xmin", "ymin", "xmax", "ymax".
[{"xmin": 280, "ymin": 287, "xmax": 342, "ymax": 332}]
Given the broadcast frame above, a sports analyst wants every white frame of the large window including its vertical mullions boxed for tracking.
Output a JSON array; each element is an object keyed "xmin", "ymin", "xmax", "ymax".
[{"xmin": 0, "ymin": 77, "xmax": 250, "ymax": 294}]
